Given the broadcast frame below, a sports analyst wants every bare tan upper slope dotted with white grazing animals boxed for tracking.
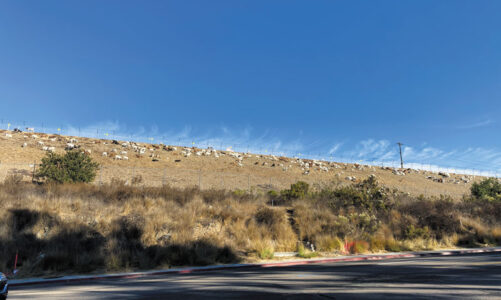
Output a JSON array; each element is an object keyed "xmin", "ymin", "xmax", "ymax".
[{"xmin": 0, "ymin": 130, "xmax": 481, "ymax": 198}]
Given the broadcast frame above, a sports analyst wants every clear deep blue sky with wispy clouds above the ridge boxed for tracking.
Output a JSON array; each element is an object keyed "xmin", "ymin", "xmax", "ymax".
[{"xmin": 0, "ymin": 0, "xmax": 501, "ymax": 172}]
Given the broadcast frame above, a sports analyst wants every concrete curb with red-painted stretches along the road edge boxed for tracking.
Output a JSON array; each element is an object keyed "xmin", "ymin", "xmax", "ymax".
[{"xmin": 9, "ymin": 247, "xmax": 501, "ymax": 288}]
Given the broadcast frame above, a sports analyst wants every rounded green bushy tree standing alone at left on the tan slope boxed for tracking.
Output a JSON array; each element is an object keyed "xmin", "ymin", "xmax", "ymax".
[{"xmin": 36, "ymin": 151, "xmax": 99, "ymax": 183}]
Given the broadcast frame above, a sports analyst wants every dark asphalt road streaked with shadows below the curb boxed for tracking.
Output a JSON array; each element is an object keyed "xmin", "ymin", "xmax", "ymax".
[{"xmin": 9, "ymin": 254, "xmax": 501, "ymax": 300}]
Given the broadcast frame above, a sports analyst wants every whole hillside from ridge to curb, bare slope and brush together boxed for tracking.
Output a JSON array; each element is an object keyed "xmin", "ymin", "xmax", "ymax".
[{"xmin": 0, "ymin": 127, "xmax": 501, "ymax": 277}]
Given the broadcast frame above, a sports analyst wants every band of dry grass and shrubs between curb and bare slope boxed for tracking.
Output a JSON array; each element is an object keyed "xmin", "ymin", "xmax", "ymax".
[{"xmin": 0, "ymin": 151, "xmax": 501, "ymax": 276}]
